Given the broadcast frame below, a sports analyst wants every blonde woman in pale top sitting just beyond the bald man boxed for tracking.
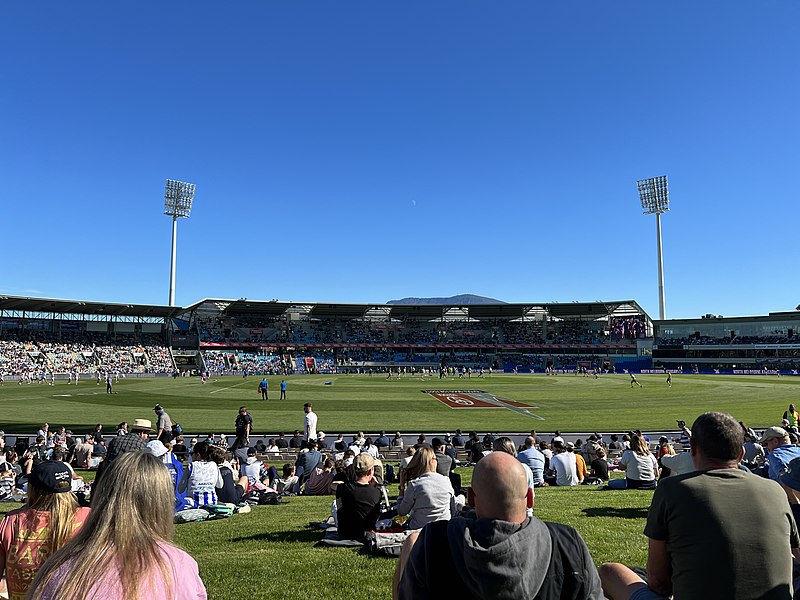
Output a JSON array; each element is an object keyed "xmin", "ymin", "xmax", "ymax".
[{"xmin": 397, "ymin": 446, "xmax": 456, "ymax": 529}]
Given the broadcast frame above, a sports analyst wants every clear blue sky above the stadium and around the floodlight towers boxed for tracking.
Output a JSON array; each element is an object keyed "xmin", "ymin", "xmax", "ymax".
[{"xmin": 0, "ymin": 0, "xmax": 800, "ymax": 318}]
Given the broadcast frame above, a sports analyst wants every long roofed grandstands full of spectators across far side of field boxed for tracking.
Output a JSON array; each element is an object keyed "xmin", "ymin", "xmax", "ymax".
[{"xmin": 0, "ymin": 296, "xmax": 800, "ymax": 377}]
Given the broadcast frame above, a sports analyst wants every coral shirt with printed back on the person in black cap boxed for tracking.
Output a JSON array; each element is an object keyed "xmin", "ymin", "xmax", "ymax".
[{"xmin": 0, "ymin": 507, "xmax": 89, "ymax": 600}]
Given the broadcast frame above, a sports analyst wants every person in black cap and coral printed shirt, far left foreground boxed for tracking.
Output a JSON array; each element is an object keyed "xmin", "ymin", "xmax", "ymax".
[{"xmin": 0, "ymin": 461, "xmax": 89, "ymax": 598}]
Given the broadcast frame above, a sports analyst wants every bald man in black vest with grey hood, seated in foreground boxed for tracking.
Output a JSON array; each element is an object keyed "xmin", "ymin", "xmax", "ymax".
[{"xmin": 392, "ymin": 452, "xmax": 603, "ymax": 600}]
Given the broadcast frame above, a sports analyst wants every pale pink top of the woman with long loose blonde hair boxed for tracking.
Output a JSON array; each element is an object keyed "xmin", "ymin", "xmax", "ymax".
[{"xmin": 42, "ymin": 542, "xmax": 208, "ymax": 600}]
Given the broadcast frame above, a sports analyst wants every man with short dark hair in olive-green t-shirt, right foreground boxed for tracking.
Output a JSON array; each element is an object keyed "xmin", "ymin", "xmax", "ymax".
[{"xmin": 600, "ymin": 412, "xmax": 800, "ymax": 600}]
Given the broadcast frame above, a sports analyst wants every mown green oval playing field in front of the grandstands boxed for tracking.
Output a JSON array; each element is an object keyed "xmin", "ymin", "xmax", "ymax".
[{"xmin": 0, "ymin": 374, "xmax": 800, "ymax": 436}]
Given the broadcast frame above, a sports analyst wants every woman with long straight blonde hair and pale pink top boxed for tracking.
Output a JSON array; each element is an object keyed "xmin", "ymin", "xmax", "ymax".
[{"xmin": 28, "ymin": 452, "xmax": 207, "ymax": 600}]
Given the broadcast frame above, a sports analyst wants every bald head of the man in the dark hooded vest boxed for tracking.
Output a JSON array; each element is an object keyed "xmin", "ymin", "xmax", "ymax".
[{"xmin": 472, "ymin": 452, "xmax": 528, "ymax": 523}]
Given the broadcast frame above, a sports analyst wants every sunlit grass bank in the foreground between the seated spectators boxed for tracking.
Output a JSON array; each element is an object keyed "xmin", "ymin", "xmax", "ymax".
[{"xmin": 0, "ymin": 469, "xmax": 653, "ymax": 600}]
